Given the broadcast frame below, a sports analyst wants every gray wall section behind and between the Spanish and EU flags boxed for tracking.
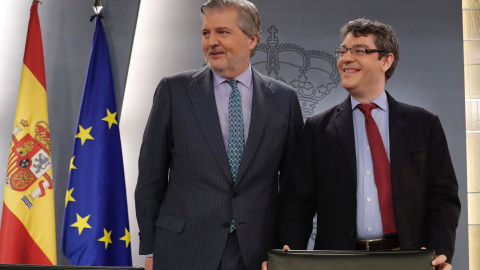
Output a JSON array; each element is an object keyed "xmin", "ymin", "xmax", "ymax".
[{"xmin": 0, "ymin": 0, "xmax": 140, "ymax": 265}]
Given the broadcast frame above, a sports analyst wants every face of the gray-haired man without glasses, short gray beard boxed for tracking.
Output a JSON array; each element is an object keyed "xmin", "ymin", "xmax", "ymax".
[{"xmin": 202, "ymin": 9, "xmax": 258, "ymax": 78}]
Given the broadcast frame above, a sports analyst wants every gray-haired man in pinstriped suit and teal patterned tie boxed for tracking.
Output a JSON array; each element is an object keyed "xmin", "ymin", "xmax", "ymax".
[{"xmin": 135, "ymin": 0, "xmax": 303, "ymax": 270}]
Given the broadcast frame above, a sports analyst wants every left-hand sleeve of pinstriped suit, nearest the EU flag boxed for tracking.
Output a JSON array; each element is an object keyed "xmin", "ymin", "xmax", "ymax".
[{"xmin": 135, "ymin": 78, "xmax": 173, "ymax": 255}]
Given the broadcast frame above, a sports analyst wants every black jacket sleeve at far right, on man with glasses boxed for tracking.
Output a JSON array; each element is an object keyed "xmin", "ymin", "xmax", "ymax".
[{"xmin": 426, "ymin": 116, "xmax": 460, "ymax": 263}]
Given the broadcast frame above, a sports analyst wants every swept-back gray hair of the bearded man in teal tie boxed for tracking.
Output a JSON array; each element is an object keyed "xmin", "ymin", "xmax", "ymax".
[{"xmin": 200, "ymin": 0, "xmax": 260, "ymax": 58}]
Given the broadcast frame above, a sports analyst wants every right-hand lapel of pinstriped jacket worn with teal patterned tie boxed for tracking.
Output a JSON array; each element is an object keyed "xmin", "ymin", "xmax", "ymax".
[{"xmin": 236, "ymin": 70, "xmax": 274, "ymax": 183}]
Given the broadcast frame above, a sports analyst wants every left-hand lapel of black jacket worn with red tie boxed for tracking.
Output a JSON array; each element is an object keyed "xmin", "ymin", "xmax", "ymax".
[{"xmin": 334, "ymin": 96, "xmax": 357, "ymax": 187}]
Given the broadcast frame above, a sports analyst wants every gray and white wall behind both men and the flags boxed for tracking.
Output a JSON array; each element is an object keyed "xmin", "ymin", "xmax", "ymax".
[{"xmin": 0, "ymin": 0, "xmax": 468, "ymax": 269}]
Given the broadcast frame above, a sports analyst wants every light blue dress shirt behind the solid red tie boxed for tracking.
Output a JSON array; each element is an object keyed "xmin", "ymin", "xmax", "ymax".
[{"xmin": 351, "ymin": 91, "xmax": 390, "ymax": 239}]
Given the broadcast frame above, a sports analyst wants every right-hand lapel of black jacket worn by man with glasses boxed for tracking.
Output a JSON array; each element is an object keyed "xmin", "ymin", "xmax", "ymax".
[{"xmin": 387, "ymin": 93, "xmax": 409, "ymax": 194}]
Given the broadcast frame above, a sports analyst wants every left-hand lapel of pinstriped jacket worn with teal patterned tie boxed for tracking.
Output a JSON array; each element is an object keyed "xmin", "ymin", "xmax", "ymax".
[{"xmin": 188, "ymin": 68, "xmax": 232, "ymax": 180}]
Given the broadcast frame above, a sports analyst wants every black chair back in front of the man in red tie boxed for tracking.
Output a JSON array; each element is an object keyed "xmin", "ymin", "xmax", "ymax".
[{"xmin": 268, "ymin": 249, "xmax": 435, "ymax": 270}]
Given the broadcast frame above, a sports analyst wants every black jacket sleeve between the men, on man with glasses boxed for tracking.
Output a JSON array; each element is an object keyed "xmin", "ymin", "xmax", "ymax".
[{"xmin": 279, "ymin": 118, "xmax": 316, "ymax": 250}]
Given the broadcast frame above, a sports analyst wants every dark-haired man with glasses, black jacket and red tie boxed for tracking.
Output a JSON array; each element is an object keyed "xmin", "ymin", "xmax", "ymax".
[{"xmin": 280, "ymin": 19, "xmax": 460, "ymax": 269}]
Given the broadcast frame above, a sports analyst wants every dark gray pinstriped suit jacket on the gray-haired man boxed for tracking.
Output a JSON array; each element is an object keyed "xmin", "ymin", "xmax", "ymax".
[{"xmin": 135, "ymin": 68, "xmax": 303, "ymax": 269}]
